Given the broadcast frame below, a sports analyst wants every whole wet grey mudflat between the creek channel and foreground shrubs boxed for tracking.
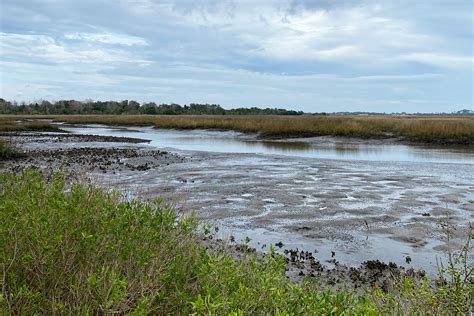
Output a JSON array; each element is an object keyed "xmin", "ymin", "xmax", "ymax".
[{"xmin": 1, "ymin": 127, "xmax": 474, "ymax": 277}]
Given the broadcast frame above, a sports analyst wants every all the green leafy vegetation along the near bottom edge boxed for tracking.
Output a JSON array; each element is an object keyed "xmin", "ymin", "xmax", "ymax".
[{"xmin": 0, "ymin": 170, "xmax": 473, "ymax": 315}]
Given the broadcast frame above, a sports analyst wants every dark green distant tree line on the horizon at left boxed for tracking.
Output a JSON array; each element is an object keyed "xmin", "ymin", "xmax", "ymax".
[{"xmin": 0, "ymin": 98, "xmax": 304, "ymax": 115}]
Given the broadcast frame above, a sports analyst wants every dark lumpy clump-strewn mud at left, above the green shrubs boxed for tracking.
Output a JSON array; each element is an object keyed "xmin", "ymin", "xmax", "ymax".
[{"xmin": 0, "ymin": 132, "xmax": 184, "ymax": 183}]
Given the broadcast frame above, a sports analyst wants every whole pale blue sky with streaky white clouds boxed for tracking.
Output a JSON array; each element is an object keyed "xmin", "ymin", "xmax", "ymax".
[{"xmin": 0, "ymin": 0, "xmax": 474, "ymax": 112}]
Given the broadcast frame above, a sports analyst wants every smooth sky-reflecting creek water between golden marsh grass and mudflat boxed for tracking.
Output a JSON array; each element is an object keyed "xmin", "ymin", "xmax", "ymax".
[{"xmin": 62, "ymin": 125, "xmax": 474, "ymax": 164}]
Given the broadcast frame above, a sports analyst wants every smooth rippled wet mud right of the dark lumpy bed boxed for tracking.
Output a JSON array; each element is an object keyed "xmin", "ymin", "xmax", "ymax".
[{"xmin": 96, "ymin": 153, "xmax": 474, "ymax": 273}]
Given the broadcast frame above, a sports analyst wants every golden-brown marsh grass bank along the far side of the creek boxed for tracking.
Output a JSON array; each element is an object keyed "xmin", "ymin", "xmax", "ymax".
[{"xmin": 7, "ymin": 115, "xmax": 474, "ymax": 144}]
